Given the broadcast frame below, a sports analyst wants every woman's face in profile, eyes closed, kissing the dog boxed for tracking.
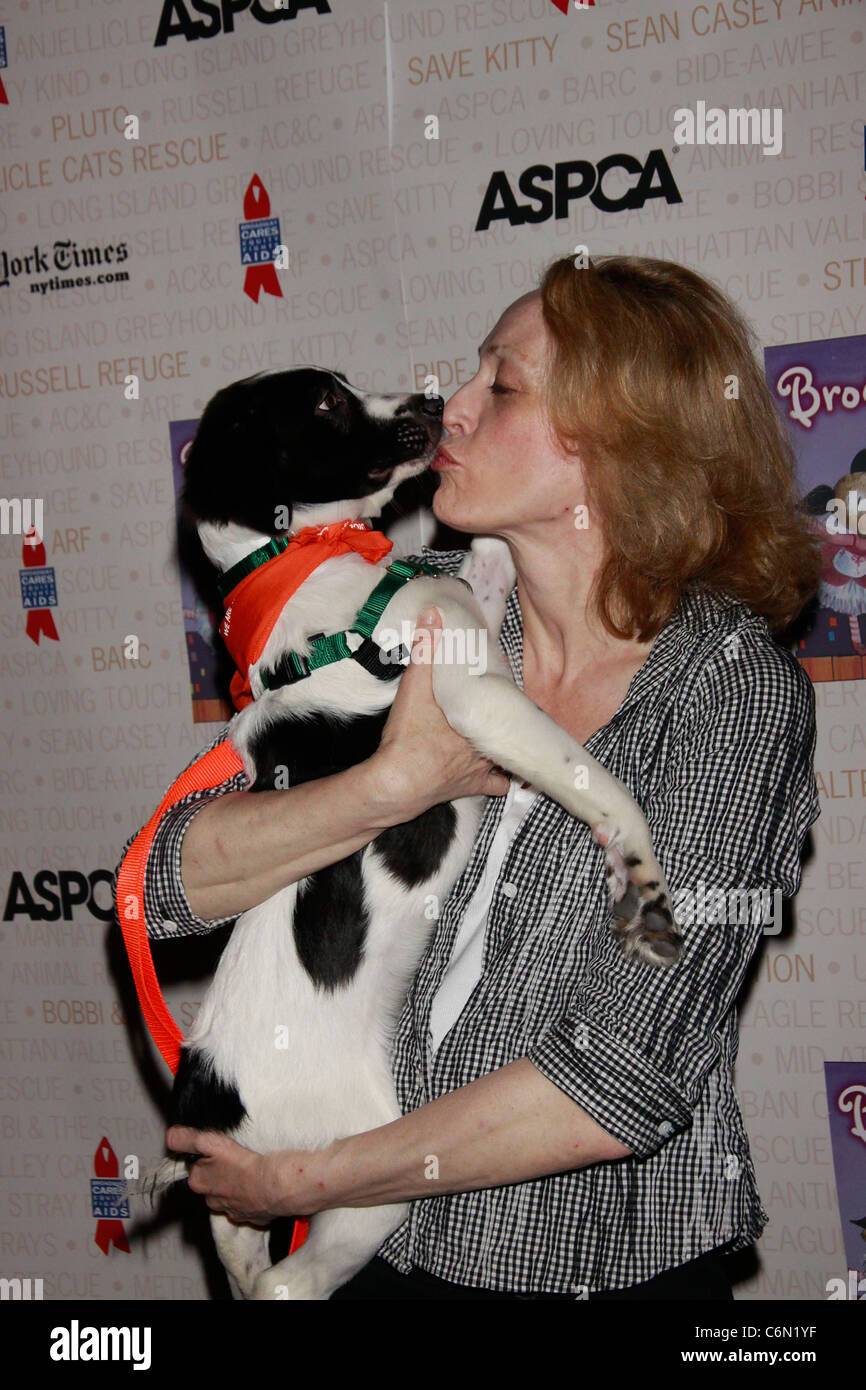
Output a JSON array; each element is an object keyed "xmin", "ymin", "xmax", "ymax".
[{"xmin": 432, "ymin": 291, "xmax": 584, "ymax": 537}]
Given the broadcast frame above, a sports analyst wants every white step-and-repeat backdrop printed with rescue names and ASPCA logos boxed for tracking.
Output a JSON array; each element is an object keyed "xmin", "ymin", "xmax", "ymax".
[{"xmin": 0, "ymin": 0, "xmax": 866, "ymax": 1301}]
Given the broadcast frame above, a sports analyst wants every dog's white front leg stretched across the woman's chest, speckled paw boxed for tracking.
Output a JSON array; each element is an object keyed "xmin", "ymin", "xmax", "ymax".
[{"xmin": 422, "ymin": 595, "xmax": 681, "ymax": 966}]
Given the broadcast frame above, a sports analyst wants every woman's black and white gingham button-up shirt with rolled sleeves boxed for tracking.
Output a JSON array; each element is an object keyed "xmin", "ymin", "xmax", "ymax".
[{"xmin": 113, "ymin": 548, "xmax": 819, "ymax": 1295}]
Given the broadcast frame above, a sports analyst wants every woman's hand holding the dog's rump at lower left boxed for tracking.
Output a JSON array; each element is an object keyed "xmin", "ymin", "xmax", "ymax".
[{"xmin": 165, "ymin": 1125, "xmax": 317, "ymax": 1226}]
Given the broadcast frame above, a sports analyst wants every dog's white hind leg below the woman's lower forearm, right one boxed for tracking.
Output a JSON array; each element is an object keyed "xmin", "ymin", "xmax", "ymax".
[{"xmin": 247, "ymin": 1205, "xmax": 409, "ymax": 1301}]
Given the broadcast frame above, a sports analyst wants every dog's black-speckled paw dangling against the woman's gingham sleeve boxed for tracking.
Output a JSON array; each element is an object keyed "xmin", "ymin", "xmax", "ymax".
[{"xmin": 596, "ymin": 826, "xmax": 683, "ymax": 966}]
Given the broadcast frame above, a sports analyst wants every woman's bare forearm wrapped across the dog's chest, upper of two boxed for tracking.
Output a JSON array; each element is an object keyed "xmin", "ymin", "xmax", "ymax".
[{"xmin": 181, "ymin": 760, "xmax": 406, "ymax": 922}]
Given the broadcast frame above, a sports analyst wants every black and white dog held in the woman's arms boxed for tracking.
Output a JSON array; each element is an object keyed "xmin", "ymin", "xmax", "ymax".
[{"xmin": 142, "ymin": 367, "xmax": 680, "ymax": 1300}]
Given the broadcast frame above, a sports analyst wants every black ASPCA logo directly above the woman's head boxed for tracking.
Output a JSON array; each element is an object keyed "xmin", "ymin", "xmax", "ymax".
[{"xmin": 475, "ymin": 150, "xmax": 683, "ymax": 232}]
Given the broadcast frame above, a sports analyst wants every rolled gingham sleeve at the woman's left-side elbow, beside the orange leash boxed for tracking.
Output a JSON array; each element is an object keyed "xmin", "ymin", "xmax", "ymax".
[{"xmin": 114, "ymin": 716, "xmax": 247, "ymax": 941}]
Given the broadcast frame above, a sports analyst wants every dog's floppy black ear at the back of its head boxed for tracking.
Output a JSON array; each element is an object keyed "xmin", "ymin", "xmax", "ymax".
[{"xmin": 182, "ymin": 381, "xmax": 292, "ymax": 535}]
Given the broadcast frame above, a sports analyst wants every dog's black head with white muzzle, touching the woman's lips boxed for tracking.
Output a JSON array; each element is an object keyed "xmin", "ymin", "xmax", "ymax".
[{"xmin": 183, "ymin": 367, "xmax": 443, "ymax": 535}]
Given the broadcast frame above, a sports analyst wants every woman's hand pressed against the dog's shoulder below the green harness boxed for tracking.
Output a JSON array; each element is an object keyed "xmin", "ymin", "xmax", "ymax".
[{"xmin": 367, "ymin": 607, "xmax": 509, "ymax": 824}]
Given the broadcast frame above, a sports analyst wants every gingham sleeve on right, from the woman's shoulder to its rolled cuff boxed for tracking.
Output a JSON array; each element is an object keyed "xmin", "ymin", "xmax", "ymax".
[{"xmin": 527, "ymin": 628, "xmax": 820, "ymax": 1156}]
